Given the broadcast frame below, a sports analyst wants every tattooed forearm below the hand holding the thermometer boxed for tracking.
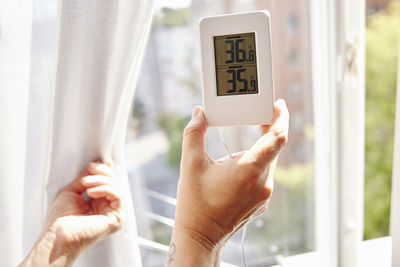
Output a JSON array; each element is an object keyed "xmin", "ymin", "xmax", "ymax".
[{"xmin": 165, "ymin": 228, "xmax": 220, "ymax": 267}]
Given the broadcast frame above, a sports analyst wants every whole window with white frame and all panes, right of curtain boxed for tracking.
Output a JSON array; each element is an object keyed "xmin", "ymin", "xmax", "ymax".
[{"xmin": 127, "ymin": 0, "xmax": 400, "ymax": 267}]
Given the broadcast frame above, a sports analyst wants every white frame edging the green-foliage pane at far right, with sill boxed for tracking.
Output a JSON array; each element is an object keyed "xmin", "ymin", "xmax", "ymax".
[{"xmin": 336, "ymin": 0, "xmax": 400, "ymax": 267}]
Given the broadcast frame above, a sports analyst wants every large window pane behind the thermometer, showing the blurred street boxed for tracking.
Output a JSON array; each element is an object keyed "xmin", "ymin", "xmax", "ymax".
[{"xmin": 127, "ymin": 0, "xmax": 315, "ymax": 266}]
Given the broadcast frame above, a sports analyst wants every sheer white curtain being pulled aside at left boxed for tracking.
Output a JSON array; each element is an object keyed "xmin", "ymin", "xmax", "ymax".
[{"xmin": 0, "ymin": 0, "xmax": 152, "ymax": 266}]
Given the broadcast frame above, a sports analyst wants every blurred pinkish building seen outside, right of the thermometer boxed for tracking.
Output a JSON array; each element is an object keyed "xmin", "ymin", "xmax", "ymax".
[{"xmin": 255, "ymin": 0, "xmax": 313, "ymax": 166}]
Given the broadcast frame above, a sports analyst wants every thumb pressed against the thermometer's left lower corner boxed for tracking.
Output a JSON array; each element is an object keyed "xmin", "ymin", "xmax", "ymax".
[{"xmin": 182, "ymin": 106, "xmax": 207, "ymax": 163}]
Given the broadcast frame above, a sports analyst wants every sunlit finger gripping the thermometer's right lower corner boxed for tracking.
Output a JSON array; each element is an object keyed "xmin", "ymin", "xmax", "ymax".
[{"xmin": 241, "ymin": 99, "xmax": 289, "ymax": 169}]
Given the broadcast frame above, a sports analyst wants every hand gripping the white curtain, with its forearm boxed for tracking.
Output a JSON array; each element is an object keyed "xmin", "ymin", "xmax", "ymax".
[{"xmin": 21, "ymin": 162, "xmax": 122, "ymax": 266}]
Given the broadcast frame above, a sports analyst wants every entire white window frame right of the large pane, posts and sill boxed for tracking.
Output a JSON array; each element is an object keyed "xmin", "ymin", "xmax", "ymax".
[{"xmin": 278, "ymin": 0, "xmax": 400, "ymax": 267}]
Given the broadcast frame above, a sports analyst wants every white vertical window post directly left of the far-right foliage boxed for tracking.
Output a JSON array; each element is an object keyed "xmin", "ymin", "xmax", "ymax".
[{"xmin": 336, "ymin": 0, "xmax": 365, "ymax": 267}]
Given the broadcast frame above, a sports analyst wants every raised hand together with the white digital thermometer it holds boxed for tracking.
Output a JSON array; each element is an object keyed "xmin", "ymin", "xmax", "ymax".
[{"xmin": 166, "ymin": 11, "xmax": 289, "ymax": 266}]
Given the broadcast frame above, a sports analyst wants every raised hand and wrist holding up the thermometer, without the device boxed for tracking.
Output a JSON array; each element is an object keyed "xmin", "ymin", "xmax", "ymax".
[{"xmin": 166, "ymin": 100, "xmax": 289, "ymax": 266}]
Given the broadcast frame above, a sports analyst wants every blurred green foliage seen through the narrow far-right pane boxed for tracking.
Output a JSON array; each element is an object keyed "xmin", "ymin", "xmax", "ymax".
[{"xmin": 364, "ymin": 1, "xmax": 400, "ymax": 239}]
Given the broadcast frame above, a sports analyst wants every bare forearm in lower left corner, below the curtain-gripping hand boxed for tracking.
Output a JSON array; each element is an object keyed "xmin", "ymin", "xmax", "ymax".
[{"xmin": 19, "ymin": 227, "xmax": 79, "ymax": 267}]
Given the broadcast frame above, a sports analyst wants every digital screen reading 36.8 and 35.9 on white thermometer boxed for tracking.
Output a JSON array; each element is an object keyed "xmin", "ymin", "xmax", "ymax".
[{"xmin": 214, "ymin": 32, "xmax": 258, "ymax": 96}]
